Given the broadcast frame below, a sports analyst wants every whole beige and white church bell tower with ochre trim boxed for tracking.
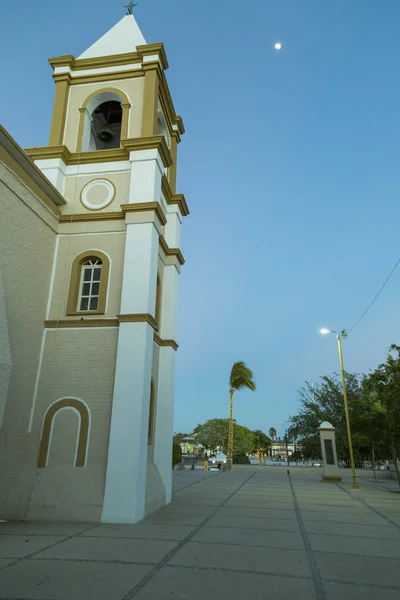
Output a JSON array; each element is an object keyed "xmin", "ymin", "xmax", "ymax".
[{"xmin": 21, "ymin": 11, "xmax": 189, "ymax": 523}]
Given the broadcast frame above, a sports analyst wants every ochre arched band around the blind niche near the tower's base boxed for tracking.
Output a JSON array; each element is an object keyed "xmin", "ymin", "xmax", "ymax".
[{"xmin": 38, "ymin": 398, "xmax": 90, "ymax": 468}]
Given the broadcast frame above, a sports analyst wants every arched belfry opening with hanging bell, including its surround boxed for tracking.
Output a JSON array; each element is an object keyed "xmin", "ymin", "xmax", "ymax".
[{"xmin": 76, "ymin": 88, "xmax": 131, "ymax": 152}]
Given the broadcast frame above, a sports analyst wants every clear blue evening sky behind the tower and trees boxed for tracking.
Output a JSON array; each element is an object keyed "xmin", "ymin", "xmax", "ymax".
[{"xmin": 0, "ymin": 0, "xmax": 400, "ymax": 432}]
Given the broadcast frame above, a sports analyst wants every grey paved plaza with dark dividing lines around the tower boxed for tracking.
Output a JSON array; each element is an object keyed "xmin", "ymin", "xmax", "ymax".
[{"xmin": 0, "ymin": 467, "xmax": 400, "ymax": 600}]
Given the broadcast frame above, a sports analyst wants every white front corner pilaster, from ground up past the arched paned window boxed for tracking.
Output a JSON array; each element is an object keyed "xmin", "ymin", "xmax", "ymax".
[{"xmin": 102, "ymin": 223, "xmax": 158, "ymax": 523}]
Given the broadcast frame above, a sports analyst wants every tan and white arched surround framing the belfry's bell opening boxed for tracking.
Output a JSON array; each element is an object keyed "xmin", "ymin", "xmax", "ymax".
[{"xmin": 76, "ymin": 87, "xmax": 131, "ymax": 152}]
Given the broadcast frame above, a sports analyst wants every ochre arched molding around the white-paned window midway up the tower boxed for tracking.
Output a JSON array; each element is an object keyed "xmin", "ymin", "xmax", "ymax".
[{"xmin": 67, "ymin": 250, "xmax": 110, "ymax": 316}]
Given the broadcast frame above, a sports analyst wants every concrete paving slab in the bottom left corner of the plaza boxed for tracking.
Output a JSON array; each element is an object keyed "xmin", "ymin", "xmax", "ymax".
[{"xmin": 0, "ymin": 560, "xmax": 151, "ymax": 600}]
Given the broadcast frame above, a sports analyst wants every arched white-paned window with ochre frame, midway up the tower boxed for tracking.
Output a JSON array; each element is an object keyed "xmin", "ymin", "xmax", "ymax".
[{"xmin": 67, "ymin": 250, "xmax": 110, "ymax": 315}]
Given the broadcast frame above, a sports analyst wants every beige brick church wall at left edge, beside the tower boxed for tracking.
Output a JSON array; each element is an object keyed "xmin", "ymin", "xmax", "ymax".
[{"xmin": 0, "ymin": 163, "xmax": 57, "ymax": 510}]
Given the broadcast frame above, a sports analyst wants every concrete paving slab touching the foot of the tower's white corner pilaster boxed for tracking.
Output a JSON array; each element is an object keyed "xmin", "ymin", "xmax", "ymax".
[{"xmin": 79, "ymin": 522, "xmax": 195, "ymax": 541}]
